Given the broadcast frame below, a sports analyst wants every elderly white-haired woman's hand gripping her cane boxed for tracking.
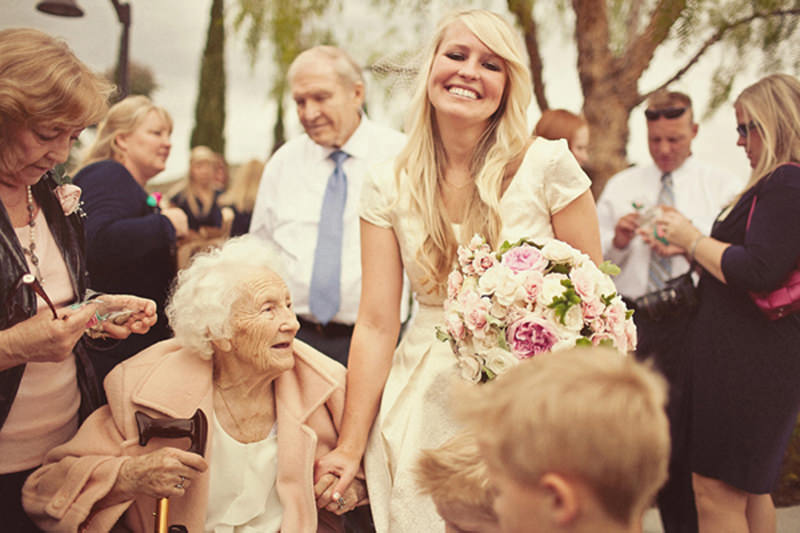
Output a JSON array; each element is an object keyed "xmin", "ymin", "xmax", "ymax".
[{"xmin": 113, "ymin": 447, "xmax": 208, "ymax": 499}]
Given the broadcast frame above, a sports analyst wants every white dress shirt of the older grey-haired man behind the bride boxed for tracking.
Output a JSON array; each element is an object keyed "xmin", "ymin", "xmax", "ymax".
[{"xmin": 250, "ymin": 114, "xmax": 405, "ymax": 324}]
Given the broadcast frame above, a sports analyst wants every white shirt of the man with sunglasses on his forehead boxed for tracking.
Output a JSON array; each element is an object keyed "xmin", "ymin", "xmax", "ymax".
[{"xmin": 597, "ymin": 156, "xmax": 744, "ymax": 298}]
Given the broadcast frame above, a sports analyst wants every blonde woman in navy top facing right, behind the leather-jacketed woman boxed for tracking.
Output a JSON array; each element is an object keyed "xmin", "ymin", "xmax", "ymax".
[{"xmin": 75, "ymin": 96, "xmax": 188, "ymax": 380}]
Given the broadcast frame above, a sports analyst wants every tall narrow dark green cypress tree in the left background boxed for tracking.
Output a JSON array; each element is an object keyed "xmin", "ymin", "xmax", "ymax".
[{"xmin": 190, "ymin": 0, "xmax": 230, "ymax": 157}]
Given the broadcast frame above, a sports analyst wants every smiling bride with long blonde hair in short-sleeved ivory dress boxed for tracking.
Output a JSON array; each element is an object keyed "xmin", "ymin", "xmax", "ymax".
[{"xmin": 316, "ymin": 10, "xmax": 602, "ymax": 532}]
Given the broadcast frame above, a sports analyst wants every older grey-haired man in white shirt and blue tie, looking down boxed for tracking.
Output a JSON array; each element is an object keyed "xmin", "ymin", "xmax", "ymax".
[{"xmin": 250, "ymin": 46, "xmax": 405, "ymax": 365}]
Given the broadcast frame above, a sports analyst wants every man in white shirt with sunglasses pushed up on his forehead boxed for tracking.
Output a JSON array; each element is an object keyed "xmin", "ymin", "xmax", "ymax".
[{"xmin": 597, "ymin": 90, "xmax": 742, "ymax": 533}]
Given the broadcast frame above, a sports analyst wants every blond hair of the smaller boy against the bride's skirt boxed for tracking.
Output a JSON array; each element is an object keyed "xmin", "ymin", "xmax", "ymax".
[{"xmin": 416, "ymin": 433, "xmax": 497, "ymax": 522}]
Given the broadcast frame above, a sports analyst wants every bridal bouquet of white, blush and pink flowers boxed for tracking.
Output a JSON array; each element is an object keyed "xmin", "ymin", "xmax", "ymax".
[{"xmin": 436, "ymin": 235, "xmax": 636, "ymax": 383}]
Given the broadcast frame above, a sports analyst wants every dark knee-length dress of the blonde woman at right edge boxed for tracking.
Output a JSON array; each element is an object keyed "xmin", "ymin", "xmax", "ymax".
[{"xmin": 688, "ymin": 165, "xmax": 800, "ymax": 494}]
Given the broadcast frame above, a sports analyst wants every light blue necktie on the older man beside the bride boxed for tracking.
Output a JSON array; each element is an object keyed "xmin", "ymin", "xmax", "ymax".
[{"xmin": 309, "ymin": 150, "xmax": 349, "ymax": 325}]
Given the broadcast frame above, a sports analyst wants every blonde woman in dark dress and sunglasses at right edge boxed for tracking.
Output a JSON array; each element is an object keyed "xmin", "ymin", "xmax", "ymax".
[{"xmin": 658, "ymin": 74, "xmax": 800, "ymax": 533}]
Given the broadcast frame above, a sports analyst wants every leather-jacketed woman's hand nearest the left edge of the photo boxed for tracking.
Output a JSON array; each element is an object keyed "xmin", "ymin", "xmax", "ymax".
[{"xmin": 5, "ymin": 303, "xmax": 97, "ymax": 363}]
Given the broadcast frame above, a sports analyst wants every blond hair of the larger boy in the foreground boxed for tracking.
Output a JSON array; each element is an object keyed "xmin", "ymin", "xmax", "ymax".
[{"xmin": 458, "ymin": 347, "xmax": 670, "ymax": 524}]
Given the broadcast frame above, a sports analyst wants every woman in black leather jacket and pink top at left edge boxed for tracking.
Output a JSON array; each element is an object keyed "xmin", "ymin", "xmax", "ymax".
[{"xmin": 0, "ymin": 29, "xmax": 155, "ymax": 532}]
